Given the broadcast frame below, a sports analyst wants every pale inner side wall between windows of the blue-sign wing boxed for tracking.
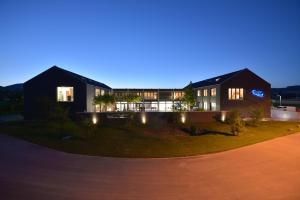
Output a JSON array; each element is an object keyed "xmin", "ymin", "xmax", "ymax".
[{"xmin": 195, "ymin": 85, "xmax": 221, "ymax": 111}]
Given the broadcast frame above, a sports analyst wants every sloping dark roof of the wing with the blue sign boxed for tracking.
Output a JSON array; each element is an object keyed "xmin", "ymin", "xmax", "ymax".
[{"xmin": 192, "ymin": 68, "xmax": 248, "ymax": 88}]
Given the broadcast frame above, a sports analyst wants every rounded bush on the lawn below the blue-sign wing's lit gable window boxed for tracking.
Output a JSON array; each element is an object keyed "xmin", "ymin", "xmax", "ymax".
[{"xmin": 227, "ymin": 110, "xmax": 245, "ymax": 135}]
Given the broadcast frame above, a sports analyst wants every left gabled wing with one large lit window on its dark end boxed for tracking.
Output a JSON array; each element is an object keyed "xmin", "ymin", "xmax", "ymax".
[{"xmin": 24, "ymin": 66, "xmax": 111, "ymax": 119}]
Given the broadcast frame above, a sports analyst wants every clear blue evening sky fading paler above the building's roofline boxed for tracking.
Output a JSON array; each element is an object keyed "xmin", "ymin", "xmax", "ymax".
[{"xmin": 0, "ymin": 0, "xmax": 300, "ymax": 88}]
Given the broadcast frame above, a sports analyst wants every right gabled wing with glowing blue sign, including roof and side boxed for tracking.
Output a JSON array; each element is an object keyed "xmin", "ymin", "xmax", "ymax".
[{"xmin": 192, "ymin": 69, "xmax": 271, "ymax": 116}]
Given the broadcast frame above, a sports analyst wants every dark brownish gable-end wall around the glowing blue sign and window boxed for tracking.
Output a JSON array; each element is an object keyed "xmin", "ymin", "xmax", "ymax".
[{"xmin": 220, "ymin": 70, "xmax": 271, "ymax": 117}]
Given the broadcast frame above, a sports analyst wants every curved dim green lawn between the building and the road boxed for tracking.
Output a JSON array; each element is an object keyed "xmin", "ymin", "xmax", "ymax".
[{"xmin": 0, "ymin": 122, "xmax": 300, "ymax": 157}]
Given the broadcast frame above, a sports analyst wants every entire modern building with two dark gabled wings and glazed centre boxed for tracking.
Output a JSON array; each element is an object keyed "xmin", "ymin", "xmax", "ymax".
[{"xmin": 24, "ymin": 66, "xmax": 271, "ymax": 119}]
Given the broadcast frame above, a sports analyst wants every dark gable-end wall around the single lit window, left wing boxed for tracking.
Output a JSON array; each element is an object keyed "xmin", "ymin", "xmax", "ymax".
[{"xmin": 24, "ymin": 68, "xmax": 86, "ymax": 119}]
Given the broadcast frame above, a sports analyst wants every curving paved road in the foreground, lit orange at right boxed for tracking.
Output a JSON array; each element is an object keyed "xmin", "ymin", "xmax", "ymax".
[{"xmin": 0, "ymin": 134, "xmax": 300, "ymax": 200}]
